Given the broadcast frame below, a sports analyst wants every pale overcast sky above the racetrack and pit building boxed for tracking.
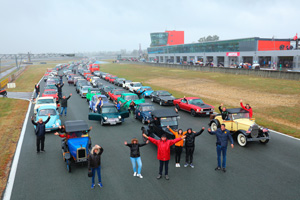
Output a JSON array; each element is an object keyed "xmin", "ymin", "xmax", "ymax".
[{"xmin": 0, "ymin": 0, "xmax": 300, "ymax": 53}]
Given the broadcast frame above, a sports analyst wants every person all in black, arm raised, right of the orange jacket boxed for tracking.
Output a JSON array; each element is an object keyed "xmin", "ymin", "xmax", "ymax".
[{"xmin": 184, "ymin": 127, "xmax": 205, "ymax": 168}]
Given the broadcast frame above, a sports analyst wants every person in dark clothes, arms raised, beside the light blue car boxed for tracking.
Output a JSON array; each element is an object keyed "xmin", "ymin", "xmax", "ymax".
[{"xmin": 31, "ymin": 113, "xmax": 50, "ymax": 153}]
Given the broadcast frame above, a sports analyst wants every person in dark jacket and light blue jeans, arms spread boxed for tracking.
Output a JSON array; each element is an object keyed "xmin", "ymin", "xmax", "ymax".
[{"xmin": 124, "ymin": 138, "xmax": 149, "ymax": 178}]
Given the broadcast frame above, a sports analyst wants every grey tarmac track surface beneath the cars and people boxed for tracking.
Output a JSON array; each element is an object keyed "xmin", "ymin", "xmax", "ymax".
[{"xmin": 7, "ymin": 73, "xmax": 300, "ymax": 200}]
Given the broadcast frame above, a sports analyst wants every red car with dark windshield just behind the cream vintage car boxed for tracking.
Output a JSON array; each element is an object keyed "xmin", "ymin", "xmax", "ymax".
[{"xmin": 173, "ymin": 97, "xmax": 215, "ymax": 117}]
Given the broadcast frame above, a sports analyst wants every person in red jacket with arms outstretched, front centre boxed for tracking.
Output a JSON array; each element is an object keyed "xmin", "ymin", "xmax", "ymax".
[{"xmin": 143, "ymin": 133, "xmax": 186, "ymax": 180}]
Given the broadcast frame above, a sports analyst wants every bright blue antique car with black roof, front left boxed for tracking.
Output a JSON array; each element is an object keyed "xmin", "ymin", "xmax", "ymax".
[{"xmin": 61, "ymin": 120, "xmax": 92, "ymax": 172}]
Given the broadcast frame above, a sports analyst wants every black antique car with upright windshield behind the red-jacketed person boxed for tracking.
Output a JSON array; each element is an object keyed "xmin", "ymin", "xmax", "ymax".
[{"xmin": 144, "ymin": 109, "xmax": 179, "ymax": 139}]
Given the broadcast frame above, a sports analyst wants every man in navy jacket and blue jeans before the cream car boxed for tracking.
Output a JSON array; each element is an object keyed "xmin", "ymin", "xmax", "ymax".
[{"xmin": 207, "ymin": 124, "xmax": 234, "ymax": 172}]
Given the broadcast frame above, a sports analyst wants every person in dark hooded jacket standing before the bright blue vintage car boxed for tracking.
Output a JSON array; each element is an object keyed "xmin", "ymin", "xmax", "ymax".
[{"xmin": 88, "ymin": 145, "xmax": 103, "ymax": 189}]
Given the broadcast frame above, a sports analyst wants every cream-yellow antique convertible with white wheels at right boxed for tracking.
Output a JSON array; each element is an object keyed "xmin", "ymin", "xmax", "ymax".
[{"xmin": 208, "ymin": 108, "xmax": 270, "ymax": 147}]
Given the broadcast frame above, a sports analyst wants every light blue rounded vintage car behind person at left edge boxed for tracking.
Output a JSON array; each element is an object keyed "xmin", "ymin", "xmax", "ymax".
[{"xmin": 35, "ymin": 105, "xmax": 61, "ymax": 132}]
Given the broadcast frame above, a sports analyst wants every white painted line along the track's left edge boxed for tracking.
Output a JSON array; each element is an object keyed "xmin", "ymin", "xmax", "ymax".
[{"xmin": 3, "ymin": 76, "xmax": 44, "ymax": 200}]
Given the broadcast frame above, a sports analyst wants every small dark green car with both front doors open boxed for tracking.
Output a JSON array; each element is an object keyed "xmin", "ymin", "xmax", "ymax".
[{"xmin": 89, "ymin": 103, "xmax": 129, "ymax": 126}]
